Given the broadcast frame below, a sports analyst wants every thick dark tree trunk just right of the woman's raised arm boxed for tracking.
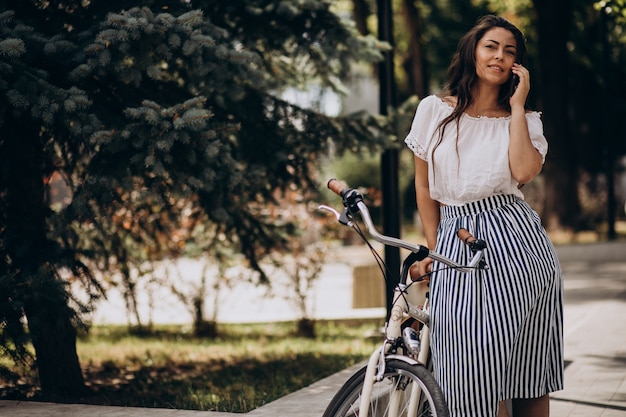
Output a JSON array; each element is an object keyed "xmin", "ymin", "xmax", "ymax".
[{"xmin": 534, "ymin": 0, "xmax": 580, "ymax": 230}]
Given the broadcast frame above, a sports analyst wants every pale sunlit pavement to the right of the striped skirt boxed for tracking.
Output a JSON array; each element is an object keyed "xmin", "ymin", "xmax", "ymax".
[{"xmin": 551, "ymin": 242, "xmax": 626, "ymax": 417}]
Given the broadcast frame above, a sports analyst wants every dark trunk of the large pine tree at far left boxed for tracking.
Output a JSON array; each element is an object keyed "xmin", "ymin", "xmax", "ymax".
[{"xmin": 0, "ymin": 117, "xmax": 85, "ymax": 397}]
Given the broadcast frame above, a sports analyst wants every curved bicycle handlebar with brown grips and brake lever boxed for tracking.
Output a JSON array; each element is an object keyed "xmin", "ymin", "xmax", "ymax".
[{"xmin": 320, "ymin": 178, "xmax": 487, "ymax": 272}]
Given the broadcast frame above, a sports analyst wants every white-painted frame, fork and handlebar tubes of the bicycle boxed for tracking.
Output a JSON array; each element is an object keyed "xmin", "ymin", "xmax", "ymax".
[{"xmin": 319, "ymin": 197, "xmax": 483, "ymax": 417}]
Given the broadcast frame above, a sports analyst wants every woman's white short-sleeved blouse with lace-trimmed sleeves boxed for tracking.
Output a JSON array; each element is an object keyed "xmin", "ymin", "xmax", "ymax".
[{"xmin": 404, "ymin": 95, "xmax": 548, "ymax": 206}]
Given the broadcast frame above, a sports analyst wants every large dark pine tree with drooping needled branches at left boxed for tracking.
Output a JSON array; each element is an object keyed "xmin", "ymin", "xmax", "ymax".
[{"xmin": 0, "ymin": 0, "xmax": 387, "ymax": 396}]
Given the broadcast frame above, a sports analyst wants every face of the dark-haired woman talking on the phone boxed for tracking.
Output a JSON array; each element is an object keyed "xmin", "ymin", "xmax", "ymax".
[{"xmin": 476, "ymin": 27, "xmax": 517, "ymax": 85}]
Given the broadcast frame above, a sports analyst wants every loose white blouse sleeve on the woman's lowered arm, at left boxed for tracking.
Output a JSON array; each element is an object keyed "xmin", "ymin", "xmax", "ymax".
[{"xmin": 404, "ymin": 95, "xmax": 447, "ymax": 161}]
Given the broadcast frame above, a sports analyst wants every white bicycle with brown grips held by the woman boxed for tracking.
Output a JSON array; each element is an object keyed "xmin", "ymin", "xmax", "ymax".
[{"xmin": 319, "ymin": 179, "xmax": 488, "ymax": 417}]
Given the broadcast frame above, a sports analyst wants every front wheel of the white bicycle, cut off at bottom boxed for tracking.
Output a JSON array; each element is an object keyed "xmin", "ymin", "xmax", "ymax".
[{"xmin": 324, "ymin": 359, "xmax": 448, "ymax": 417}]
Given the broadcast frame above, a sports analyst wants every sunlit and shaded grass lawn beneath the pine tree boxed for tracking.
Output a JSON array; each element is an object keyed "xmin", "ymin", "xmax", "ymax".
[{"xmin": 0, "ymin": 320, "xmax": 382, "ymax": 413}]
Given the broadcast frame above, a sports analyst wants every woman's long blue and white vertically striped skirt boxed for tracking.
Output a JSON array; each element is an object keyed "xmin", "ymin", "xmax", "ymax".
[{"xmin": 430, "ymin": 195, "xmax": 563, "ymax": 417}]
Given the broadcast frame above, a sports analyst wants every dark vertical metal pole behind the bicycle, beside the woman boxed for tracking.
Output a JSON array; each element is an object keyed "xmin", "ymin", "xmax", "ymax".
[{"xmin": 376, "ymin": 0, "xmax": 401, "ymax": 316}]
